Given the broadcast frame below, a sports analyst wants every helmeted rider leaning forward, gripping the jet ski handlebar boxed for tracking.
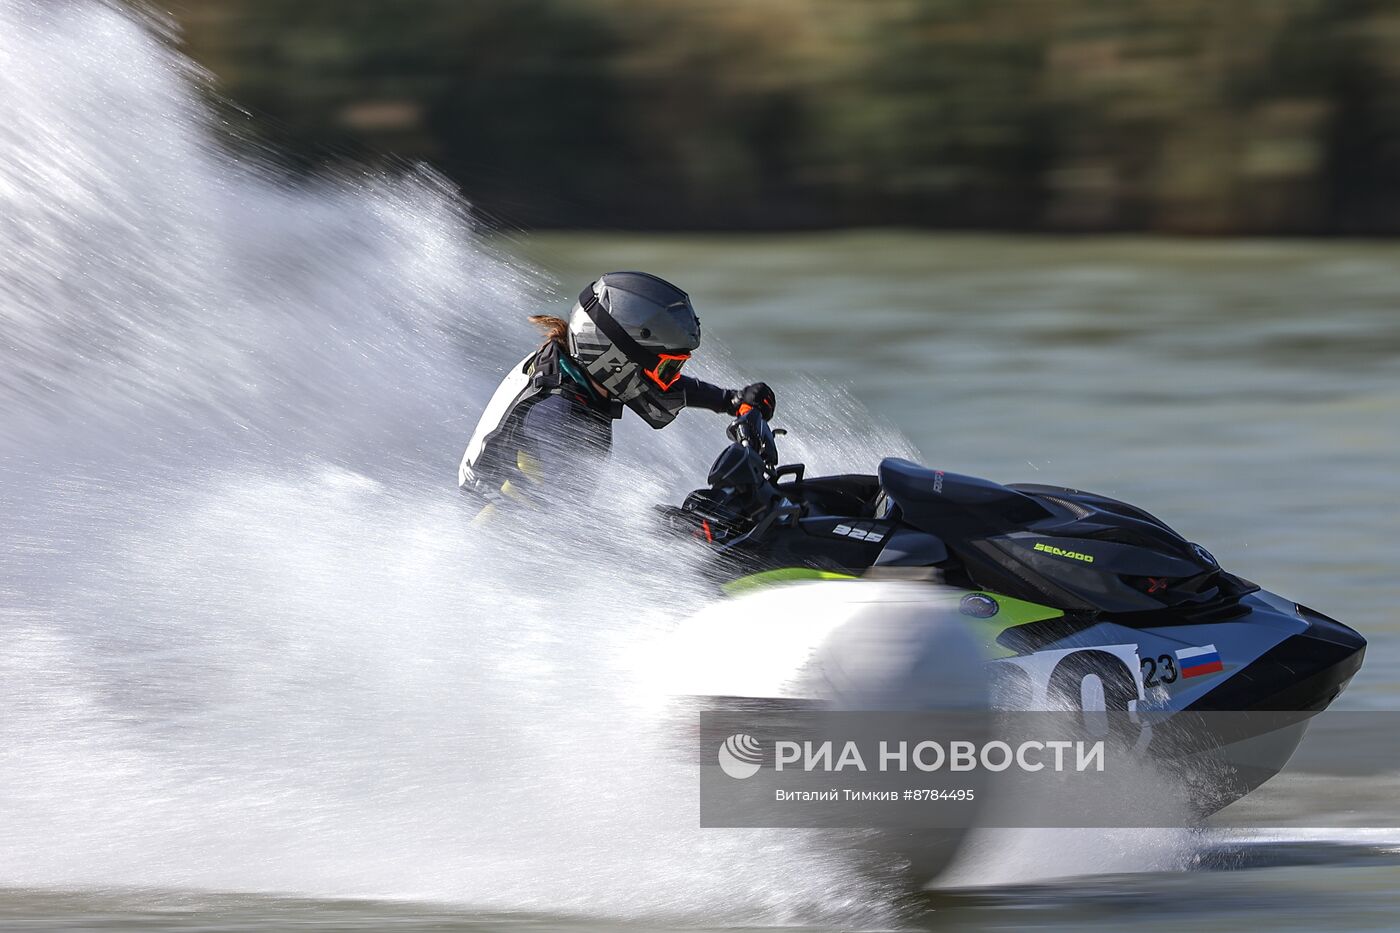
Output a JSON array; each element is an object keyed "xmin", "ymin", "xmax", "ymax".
[{"xmin": 458, "ymin": 272, "xmax": 774, "ymax": 504}]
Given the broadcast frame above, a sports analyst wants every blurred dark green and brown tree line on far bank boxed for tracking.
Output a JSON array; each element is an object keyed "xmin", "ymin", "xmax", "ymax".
[{"xmin": 169, "ymin": 0, "xmax": 1400, "ymax": 234}]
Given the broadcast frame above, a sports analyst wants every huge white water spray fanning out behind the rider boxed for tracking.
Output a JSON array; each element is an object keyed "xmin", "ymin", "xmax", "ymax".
[{"xmin": 0, "ymin": 0, "xmax": 907, "ymax": 922}]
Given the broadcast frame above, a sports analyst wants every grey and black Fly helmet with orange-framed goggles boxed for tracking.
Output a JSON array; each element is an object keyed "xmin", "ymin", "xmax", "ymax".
[{"xmin": 568, "ymin": 272, "xmax": 700, "ymax": 427}]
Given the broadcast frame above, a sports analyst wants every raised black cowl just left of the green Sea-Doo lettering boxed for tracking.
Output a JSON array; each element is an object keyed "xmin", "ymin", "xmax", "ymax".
[{"xmin": 879, "ymin": 457, "xmax": 1050, "ymax": 534}]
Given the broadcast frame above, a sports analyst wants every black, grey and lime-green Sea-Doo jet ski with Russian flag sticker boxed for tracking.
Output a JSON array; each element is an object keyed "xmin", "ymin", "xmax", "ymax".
[{"xmin": 658, "ymin": 410, "xmax": 1366, "ymax": 713}]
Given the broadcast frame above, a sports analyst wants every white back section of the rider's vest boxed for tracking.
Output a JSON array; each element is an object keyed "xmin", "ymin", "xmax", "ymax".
[{"xmin": 456, "ymin": 340, "xmax": 622, "ymax": 497}]
